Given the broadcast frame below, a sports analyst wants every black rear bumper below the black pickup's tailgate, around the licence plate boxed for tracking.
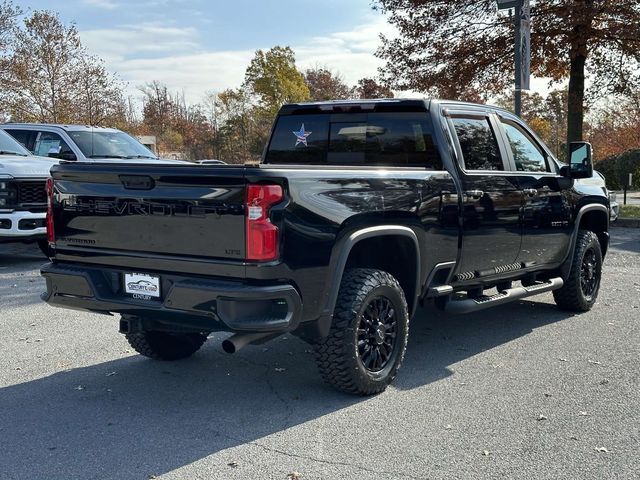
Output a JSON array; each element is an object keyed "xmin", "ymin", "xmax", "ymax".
[{"xmin": 41, "ymin": 263, "xmax": 302, "ymax": 333}]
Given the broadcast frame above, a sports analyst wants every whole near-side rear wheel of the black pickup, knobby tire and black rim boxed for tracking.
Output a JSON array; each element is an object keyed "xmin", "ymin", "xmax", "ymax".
[{"xmin": 315, "ymin": 268, "xmax": 409, "ymax": 395}]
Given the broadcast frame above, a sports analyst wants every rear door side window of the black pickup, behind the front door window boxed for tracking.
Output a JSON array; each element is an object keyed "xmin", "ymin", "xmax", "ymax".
[{"xmin": 452, "ymin": 117, "xmax": 504, "ymax": 171}]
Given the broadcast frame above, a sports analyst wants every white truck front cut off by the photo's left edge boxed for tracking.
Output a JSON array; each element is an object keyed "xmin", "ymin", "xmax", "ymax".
[{"xmin": 0, "ymin": 130, "xmax": 58, "ymax": 254}]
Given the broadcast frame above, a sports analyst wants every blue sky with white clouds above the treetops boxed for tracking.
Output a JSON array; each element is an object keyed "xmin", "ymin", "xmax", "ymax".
[{"xmin": 17, "ymin": 0, "xmax": 392, "ymax": 101}]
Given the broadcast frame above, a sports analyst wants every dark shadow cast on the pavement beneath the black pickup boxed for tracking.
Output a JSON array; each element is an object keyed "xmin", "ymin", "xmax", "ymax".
[{"xmin": 0, "ymin": 301, "xmax": 566, "ymax": 479}]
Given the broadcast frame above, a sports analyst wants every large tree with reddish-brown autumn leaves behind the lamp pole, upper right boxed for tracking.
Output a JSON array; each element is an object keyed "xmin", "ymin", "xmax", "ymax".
[{"xmin": 375, "ymin": 0, "xmax": 640, "ymax": 141}]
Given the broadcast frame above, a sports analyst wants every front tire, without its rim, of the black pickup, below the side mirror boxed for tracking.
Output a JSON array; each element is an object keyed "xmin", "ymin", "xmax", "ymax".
[{"xmin": 553, "ymin": 230, "xmax": 602, "ymax": 312}]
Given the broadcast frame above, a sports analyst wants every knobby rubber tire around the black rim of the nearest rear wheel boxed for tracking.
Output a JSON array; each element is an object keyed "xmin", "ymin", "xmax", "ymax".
[{"xmin": 314, "ymin": 268, "xmax": 409, "ymax": 395}]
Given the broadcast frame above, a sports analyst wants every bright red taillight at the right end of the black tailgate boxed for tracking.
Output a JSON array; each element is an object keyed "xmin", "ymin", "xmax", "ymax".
[{"xmin": 246, "ymin": 185, "xmax": 283, "ymax": 262}]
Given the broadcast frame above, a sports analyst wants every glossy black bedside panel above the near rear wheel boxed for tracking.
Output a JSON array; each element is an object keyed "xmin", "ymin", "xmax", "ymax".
[{"xmin": 247, "ymin": 165, "xmax": 459, "ymax": 320}]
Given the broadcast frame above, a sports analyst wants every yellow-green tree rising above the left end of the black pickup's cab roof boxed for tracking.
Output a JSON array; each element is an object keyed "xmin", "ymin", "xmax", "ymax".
[{"xmin": 244, "ymin": 46, "xmax": 310, "ymax": 121}]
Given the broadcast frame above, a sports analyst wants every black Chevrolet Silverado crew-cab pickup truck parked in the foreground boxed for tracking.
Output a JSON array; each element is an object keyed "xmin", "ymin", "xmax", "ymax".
[{"xmin": 42, "ymin": 100, "xmax": 610, "ymax": 395}]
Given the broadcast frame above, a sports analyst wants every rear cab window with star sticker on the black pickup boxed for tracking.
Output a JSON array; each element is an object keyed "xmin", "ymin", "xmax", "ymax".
[{"xmin": 265, "ymin": 112, "xmax": 443, "ymax": 170}]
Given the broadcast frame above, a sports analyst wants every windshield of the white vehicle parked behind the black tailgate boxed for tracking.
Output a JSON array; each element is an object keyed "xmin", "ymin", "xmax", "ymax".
[{"xmin": 68, "ymin": 131, "xmax": 158, "ymax": 159}]
